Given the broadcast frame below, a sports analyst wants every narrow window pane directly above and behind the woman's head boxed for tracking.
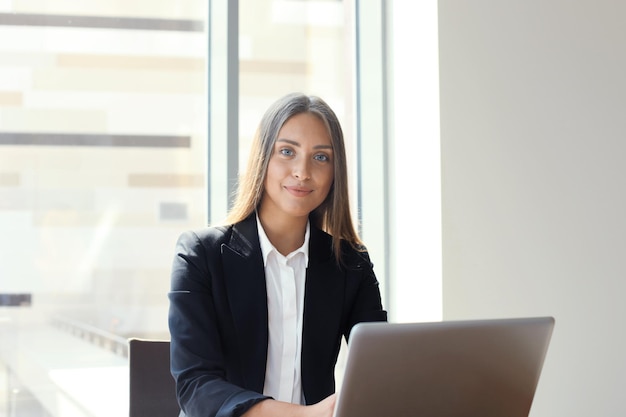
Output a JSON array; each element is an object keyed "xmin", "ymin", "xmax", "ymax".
[{"xmin": 239, "ymin": 0, "xmax": 356, "ymax": 179}]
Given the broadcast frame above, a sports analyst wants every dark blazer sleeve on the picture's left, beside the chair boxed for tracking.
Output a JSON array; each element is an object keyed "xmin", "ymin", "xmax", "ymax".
[{"xmin": 168, "ymin": 232, "xmax": 268, "ymax": 417}]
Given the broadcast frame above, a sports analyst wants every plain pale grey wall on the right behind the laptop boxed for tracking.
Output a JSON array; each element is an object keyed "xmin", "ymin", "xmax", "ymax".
[{"xmin": 439, "ymin": 0, "xmax": 626, "ymax": 417}]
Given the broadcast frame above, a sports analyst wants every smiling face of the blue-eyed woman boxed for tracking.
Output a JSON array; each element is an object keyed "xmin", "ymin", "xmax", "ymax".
[{"xmin": 261, "ymin": 113, "xmax": 334, "ymax": 221}]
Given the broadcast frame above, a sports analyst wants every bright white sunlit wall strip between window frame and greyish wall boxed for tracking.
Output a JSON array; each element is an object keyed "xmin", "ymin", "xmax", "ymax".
[{"xmin": 387, "ymin": 0, "xmax": 442, "ymax": 322}]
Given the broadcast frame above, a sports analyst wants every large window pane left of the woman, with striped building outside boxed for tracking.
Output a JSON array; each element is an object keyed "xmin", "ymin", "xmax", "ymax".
[{"xmin": 0, "ymin": 0, "xmax": 207, "ymax": 417}]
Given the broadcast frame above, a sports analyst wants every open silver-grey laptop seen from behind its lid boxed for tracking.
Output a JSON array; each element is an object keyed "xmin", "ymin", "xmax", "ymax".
[{"xmin": 334, "ymin": 317, "xmax": 555, "ymax": 417}]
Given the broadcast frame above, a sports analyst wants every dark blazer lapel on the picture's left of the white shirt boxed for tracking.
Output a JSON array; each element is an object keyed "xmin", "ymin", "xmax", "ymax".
[{"xmin": 222, "ymin": 216, "xmax": 268, "ymax": 392}]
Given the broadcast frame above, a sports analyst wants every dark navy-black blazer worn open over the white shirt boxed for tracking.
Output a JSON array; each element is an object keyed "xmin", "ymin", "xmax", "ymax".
[{"xmin": 169, "ymin": 215, "xmax": 387, "ymax": 417}]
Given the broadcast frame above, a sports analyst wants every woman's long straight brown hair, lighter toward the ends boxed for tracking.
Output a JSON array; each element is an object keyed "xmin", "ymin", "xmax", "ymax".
[{"xmin": 226, "ymin": 93, "xmax": 363, "ymax": 262}]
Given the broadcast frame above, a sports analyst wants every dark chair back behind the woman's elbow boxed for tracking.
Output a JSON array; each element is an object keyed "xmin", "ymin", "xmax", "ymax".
[{"xmin": 128, "ymin": 338, "xmax": 180, "ymax": 417}]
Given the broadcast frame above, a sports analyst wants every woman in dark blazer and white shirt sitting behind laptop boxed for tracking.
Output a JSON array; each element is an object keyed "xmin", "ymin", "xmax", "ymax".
[{"xmin": 169, "ymin": 94, "xmax": 387, "ymax": 417}]
